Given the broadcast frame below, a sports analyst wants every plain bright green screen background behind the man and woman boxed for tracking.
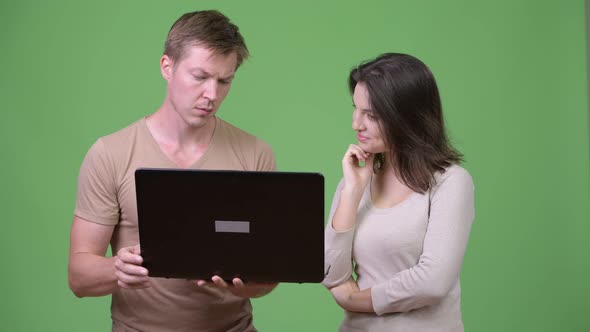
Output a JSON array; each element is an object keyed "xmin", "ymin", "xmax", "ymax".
[{"xmin": 0, "ymin": 0, "xmax": 590, "ymax": 331}]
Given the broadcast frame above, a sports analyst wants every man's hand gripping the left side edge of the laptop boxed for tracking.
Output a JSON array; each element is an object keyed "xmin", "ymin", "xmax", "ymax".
[{"xmin": 115, "ymin": 245, "xmax": 150, "ymax": 289}]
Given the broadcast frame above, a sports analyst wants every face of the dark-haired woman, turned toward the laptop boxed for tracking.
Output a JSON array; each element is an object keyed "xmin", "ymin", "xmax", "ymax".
[{"xmin": 352, "ymin": 82, "xmax": 387, "ymax": 153}]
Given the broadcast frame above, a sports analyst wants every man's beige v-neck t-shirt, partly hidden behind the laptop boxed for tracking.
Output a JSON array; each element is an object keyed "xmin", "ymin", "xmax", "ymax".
[{"xmin": 74, "ymin": 118, "xmax": 276, "ymax": 332}]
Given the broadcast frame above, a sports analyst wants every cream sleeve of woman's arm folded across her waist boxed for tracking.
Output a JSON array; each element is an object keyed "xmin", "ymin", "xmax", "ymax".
[{"xmin": 370, "ymin": 166, "xmax": 475, "ymax": 315}]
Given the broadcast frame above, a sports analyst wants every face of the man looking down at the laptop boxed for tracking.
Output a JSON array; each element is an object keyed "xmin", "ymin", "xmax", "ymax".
[{"xmin": 160, "ymin": 46, "xmax": 237, "ymax": 128}]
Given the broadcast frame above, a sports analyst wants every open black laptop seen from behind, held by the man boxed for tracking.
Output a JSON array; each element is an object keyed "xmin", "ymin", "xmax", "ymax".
[{"xmin": 135, "ymin": 168, "xmax": 324, "ymax": 283}]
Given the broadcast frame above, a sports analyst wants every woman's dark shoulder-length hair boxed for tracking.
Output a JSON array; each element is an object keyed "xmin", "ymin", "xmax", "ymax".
[{"xmin": 348, "ymin": 53, "xmax": 463, "ymax": 193}]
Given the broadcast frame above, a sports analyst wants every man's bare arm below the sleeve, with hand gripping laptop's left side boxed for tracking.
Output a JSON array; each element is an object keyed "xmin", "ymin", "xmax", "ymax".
[{"xmin": 68, "ymin": 217, "xmax": 149, "ymax": 297}]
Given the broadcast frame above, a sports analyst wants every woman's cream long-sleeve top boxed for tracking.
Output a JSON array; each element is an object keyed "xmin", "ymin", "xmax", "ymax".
[{"xmin": 323, "ymin": 165, "xmax": 474, "ymax": 332}]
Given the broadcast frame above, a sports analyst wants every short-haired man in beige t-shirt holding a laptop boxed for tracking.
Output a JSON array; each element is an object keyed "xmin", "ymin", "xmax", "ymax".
[{"xmin": 68, "ymin": 11, "xmax": 276, "ymax": 331}]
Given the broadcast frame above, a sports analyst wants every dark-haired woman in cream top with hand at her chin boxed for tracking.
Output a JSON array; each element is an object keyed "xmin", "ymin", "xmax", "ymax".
[{"xmin": 323, "ymin": 53, "xmax": 474, "ymax": 332}]
